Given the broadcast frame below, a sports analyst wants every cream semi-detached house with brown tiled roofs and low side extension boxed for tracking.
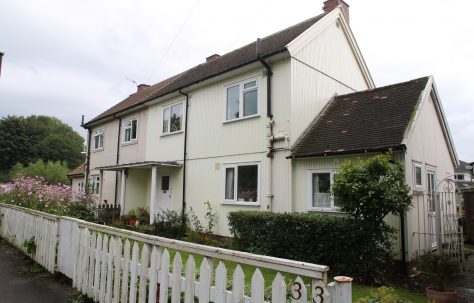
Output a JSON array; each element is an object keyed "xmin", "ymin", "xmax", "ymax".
[{"xmin": 83, "ymin": 0, "xmax": 458, "ymax": 257}]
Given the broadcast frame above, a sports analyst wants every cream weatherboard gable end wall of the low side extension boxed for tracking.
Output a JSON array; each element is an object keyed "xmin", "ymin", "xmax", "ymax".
[{"xmin": 405, "ymin": 91, "xmax": 454, "ymax": 259}]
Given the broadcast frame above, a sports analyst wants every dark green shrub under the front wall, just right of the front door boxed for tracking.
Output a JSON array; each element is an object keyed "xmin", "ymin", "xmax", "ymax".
[{"xmin": 151, "ymin": 210, "xmax": 189, "ymax": 240}]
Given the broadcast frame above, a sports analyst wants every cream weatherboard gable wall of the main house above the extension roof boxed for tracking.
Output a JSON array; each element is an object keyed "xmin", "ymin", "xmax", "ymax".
[{"xmin": 291, "ymin": 16, "xmax": 370, "ymax": 143}]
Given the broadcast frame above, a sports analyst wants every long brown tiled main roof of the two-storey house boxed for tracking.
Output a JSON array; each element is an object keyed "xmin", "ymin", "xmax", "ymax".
[{"xmin": 85, "ymin": 13, "xmax": 327, "ymax": 126}]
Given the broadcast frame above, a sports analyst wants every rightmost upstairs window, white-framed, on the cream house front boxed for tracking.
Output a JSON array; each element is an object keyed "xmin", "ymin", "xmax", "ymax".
[{"xmin": 226, "ymin": 79, "xmax": 258, "ymax": 121}]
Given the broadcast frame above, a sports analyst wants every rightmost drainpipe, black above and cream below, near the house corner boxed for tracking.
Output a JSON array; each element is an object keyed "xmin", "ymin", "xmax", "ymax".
[{"xmin": 256, "ymin": 38, "xmax": 274, "ymax": 211}]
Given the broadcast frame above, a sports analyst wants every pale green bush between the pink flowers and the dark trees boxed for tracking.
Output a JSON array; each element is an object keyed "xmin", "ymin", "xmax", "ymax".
[{"xmin": 10, "ymin": 160, "xmax": 69, "ymax": 184}]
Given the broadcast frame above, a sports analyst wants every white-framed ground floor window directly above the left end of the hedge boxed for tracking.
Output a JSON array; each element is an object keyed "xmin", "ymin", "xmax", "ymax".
[{"xmin": 224, "ymin": 163, "xmax": 260, "ymax": 204}]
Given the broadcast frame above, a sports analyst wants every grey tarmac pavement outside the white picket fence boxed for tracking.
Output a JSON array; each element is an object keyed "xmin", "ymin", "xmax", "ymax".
[{"xmin": 0, "ymin": 239, "xmax": 74, "ymax": 303}]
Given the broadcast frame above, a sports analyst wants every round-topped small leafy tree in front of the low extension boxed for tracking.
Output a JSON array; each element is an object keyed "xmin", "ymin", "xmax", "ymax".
[{"xmin": 332, "ymin": 153, "xmax": 412, "ymax": 283}]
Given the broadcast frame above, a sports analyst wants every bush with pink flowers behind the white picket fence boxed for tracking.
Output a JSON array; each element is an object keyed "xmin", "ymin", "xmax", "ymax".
[{"xmin": 0, "ymin": 176, "xmax": 96, "ymax": 220}]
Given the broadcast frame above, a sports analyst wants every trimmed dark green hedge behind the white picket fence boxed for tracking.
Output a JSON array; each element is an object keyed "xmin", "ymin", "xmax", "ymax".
[{"xmin": 228, "ymin": 211, "xmax": 392, "ymax": 283}]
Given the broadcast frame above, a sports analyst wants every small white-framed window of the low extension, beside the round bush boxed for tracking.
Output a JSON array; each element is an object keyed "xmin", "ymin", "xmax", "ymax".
[{"xmin": 308, "ymin": 170, "xmax": 337, "ymax": 210}]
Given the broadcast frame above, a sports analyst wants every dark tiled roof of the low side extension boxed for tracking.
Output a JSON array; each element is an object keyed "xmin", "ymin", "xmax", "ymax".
[{"xmin": 291, "ymin": 77, "xmax": 429, "ymax": 158}]
